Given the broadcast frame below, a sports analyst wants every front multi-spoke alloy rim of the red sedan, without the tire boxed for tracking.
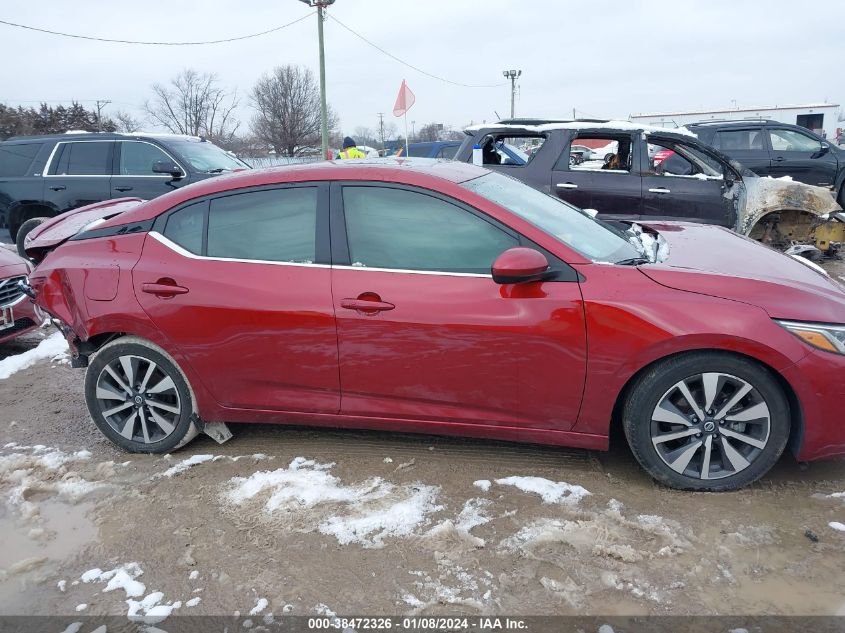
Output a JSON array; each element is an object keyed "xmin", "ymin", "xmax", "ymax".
[{"xmin": 651, "ymin": 372, "xmax": 771, "ymax": 479}]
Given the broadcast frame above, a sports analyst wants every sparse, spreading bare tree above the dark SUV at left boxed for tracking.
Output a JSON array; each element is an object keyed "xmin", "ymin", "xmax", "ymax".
[{"xmin": 144, "ymin": 68, "xmax": 240, "ymax": 144}]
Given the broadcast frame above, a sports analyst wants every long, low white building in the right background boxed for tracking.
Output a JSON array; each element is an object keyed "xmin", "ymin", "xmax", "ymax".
[{"xmin": 630, "ymin": 103, "xmax": 845, "ymax": 139}]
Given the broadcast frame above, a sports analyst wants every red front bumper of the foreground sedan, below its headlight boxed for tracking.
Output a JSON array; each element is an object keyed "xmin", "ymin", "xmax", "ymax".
[{"xmin": 782, "ymin": 351, "xmax": 845, "ymax": 461}]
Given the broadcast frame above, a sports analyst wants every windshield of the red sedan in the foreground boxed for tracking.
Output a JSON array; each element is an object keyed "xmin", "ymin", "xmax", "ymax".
[{"xmin": 461, "ymin": 174, "xmax": 642, "ymax": 263}]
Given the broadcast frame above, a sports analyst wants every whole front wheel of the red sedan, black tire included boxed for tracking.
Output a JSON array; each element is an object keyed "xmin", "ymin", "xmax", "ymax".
[{"xmin": 623, "ymin": 352, "xmax": 790, "ymax": 491}]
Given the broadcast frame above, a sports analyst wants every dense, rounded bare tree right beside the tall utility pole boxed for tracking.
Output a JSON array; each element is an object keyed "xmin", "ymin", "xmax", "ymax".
[{"xmin": 251, "ymin": 65, "xmax": 337, "ymax": 156}]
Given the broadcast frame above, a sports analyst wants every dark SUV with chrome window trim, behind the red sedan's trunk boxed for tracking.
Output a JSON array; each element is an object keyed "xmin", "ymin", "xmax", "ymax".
[{"xmin": 0, "ymin": 133, "xmax": 249, "ymax": 251}]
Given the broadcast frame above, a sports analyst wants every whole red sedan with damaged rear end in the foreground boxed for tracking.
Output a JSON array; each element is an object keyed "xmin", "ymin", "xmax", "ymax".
[{"xmin": 27, "ymin": 159, "xmax": 845, "ymax": 490}]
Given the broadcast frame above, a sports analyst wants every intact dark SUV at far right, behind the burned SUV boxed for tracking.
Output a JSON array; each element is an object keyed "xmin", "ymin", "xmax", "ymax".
[{"xmin": 686, "ymin": 119, "xmax": 845, "ymax": 206}]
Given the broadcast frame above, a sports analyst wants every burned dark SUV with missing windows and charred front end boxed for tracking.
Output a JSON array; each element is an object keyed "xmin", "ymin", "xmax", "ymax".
[{"xmin": 455, "ymin": 120, "xmax": 845, "ymax": 254}]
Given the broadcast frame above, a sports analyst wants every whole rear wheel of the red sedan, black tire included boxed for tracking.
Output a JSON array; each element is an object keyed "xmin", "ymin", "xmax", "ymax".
[{"xmin": 85, "ymin": 336, "xmax": 197, "ymax": 453}]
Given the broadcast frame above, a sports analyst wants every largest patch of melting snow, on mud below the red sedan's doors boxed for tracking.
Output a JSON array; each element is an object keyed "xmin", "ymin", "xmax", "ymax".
[{"xmin": 220, "ymin": 457, "xmax": 442, "ymax": 547}]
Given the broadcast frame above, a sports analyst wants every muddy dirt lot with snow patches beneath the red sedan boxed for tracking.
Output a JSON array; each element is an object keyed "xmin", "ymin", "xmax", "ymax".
[{"xmin": 0, "ymin": 241, "xmax": 845, "ymax": 621}]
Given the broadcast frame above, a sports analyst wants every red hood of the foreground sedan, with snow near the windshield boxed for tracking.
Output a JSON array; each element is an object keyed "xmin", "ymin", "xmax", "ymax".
[{"xmin": 640, "ymin": 222, "xmax": 845, "ymax": 323}]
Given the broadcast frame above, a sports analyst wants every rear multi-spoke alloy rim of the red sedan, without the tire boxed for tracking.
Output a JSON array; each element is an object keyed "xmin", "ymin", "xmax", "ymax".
[{"xmin": 96, "ymin": 355, "xmax": 182, "ymax": 444}]
